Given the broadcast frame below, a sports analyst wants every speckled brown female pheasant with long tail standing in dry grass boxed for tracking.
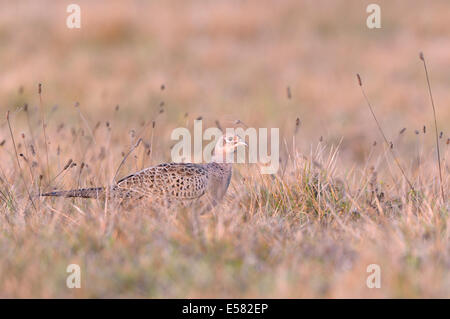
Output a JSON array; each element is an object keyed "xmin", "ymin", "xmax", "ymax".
[{"xmin": 40, "ymin": 134, "xmax": 247, "ymax": 210}]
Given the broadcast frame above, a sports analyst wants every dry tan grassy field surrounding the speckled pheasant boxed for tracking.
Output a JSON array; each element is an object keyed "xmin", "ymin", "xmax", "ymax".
[{"xmin": 0, "ymin": 0, "xmax": 450, "ymax": 298}]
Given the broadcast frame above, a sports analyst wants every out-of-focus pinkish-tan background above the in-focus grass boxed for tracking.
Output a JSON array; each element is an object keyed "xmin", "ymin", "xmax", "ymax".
[{"xmin": 0, "ymin": 0, "xmax": 450, "ymax": 168}]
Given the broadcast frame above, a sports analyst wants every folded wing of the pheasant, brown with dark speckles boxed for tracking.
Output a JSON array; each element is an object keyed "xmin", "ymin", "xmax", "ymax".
[{"xmin": 117, "ymin": 163, "xmax": 208, "ymax": 200}]
